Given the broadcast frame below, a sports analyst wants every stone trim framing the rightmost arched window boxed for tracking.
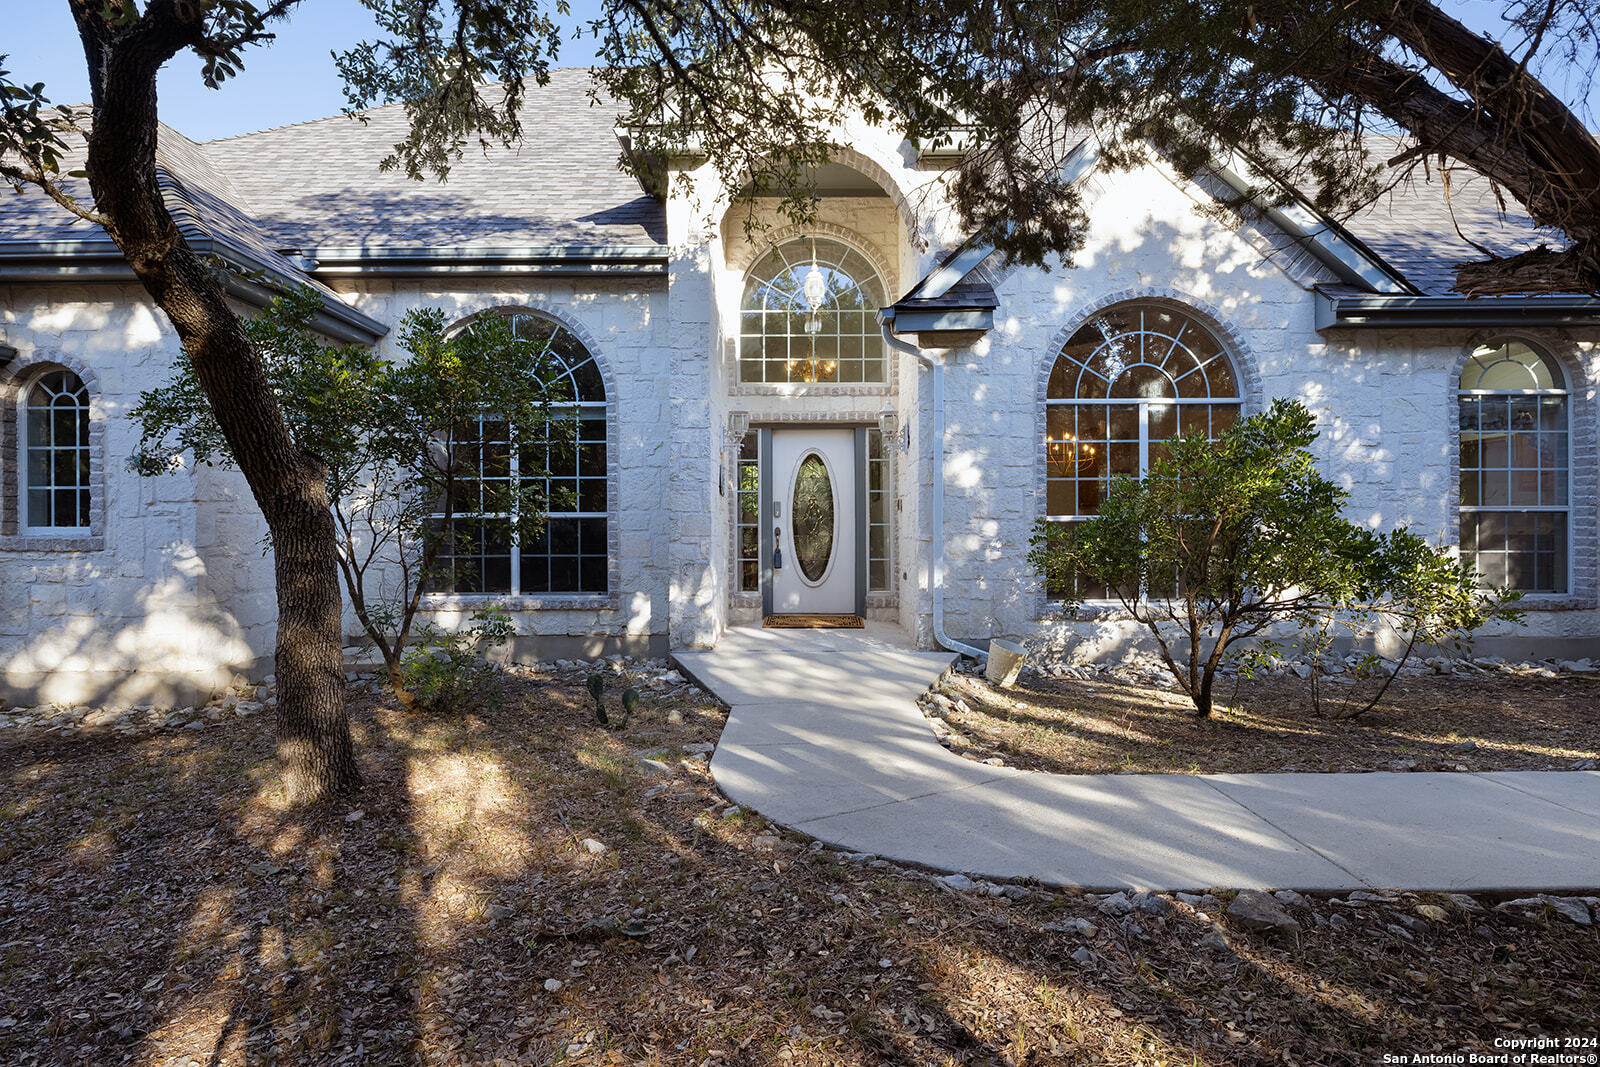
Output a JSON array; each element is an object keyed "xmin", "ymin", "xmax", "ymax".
[{"xmin": 1445, "ymin": 328, "xmax": 1600, "ymax": 611}]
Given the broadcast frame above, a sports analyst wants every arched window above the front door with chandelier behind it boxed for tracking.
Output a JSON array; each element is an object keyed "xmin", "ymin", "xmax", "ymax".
[{"xmin": 739, "ymin": 237, "xmax": 886, "ymax": 382}]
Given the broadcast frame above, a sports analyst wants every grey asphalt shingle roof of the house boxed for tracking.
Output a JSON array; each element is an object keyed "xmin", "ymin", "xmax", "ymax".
[{"xmin": 0, "ymin": 79, "xmax": 1560, "ymax": 296}]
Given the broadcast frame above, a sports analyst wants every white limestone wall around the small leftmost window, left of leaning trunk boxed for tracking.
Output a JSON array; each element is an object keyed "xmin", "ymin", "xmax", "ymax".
[{"xmin": 0, "ymin": 285, "xmax": 259, "ymax": 702}]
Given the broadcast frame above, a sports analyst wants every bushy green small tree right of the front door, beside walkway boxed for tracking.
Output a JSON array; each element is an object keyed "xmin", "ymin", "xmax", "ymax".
[{"xmin": 1029, "ymin": 400, "xmax": 1515, "ymax": 717}]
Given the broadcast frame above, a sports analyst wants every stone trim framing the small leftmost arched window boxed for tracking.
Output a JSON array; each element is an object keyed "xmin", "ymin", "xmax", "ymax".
[{"xmin": 0, "ymin": 350, "xmax": 106, "ymax": 552}]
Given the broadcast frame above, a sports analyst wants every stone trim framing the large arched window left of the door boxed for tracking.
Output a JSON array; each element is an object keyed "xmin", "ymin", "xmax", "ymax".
[{"xmin": 422, "ymin": 299, "xmax": 622, "ymax": 611}]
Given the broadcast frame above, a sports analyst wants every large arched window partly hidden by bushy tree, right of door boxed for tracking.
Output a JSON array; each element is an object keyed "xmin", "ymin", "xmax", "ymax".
[{"xmin": 1045, "ymin": 302, "xmax": 1240, "ymax": 595}]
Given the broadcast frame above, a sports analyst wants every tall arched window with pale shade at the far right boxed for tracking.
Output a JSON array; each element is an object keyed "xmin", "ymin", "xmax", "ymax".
[{"xmin": 1459, "ymin": 341, "xmax": 1571, "ymax": 593}]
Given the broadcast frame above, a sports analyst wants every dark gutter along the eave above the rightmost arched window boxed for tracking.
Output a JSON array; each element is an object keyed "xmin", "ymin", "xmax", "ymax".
[{"xmin": 1312, "ymin": 290, "xmax": 1600, "ymax": 333}]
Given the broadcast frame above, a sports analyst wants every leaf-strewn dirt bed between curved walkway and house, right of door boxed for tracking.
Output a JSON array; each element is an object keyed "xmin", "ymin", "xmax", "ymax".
[{"xmin": 942, "ymin": 672, "xmax": 1600, "ymax": 774}]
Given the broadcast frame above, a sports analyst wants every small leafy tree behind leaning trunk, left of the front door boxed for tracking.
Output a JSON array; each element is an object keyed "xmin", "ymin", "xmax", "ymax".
[{"xmin": 131, "ymin": 291, "xmax": 571, "ymax": 707}]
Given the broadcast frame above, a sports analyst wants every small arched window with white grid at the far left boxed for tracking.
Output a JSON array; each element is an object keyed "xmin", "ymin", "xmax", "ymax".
[{"xmin": 22, "ymin": 371, "xmax": 90, "ymax": 533}]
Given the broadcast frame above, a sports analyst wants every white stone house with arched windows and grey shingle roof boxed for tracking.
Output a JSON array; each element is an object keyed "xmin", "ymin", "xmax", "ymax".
[{"xmin": 0, "ymin": 70, "xmax": 1600, "ymax": 701}]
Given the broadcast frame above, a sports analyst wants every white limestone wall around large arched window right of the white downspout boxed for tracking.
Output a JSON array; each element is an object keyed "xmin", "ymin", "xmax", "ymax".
[{"xmin": 946, "ymin": 160, "xmax": 1600, "ymax": 657}]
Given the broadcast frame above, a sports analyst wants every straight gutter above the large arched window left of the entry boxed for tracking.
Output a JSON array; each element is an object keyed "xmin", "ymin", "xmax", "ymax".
[{"xmin": 299, "ymin": 245, "xmax": 667, "ymax": 278}]
